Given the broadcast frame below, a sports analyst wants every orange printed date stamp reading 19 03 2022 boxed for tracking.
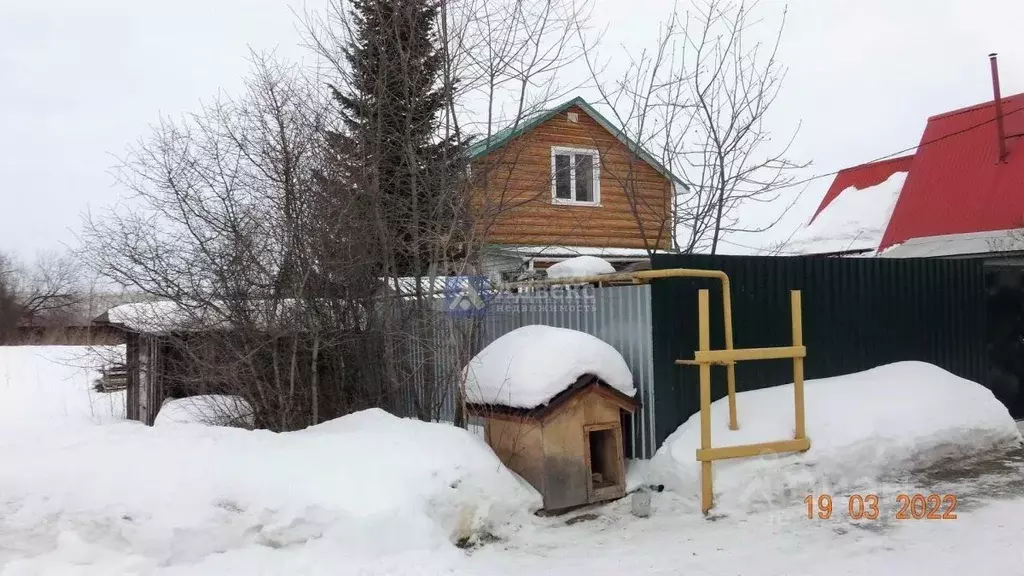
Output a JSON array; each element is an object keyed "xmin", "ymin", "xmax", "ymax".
[{"xmin": 804, "ymin": 494, "xmax": 956, "ymax": 520}]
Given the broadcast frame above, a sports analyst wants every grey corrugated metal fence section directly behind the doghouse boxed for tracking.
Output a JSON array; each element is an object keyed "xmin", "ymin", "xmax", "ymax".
[{"xmin": 476, "ymin": 286, "xmax": 656, "ymax": 458}]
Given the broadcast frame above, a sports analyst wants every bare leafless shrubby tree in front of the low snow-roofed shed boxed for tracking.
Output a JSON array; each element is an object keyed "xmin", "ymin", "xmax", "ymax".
[{"xmin": 83, "ymin": 54, "xmax": 388, "ymax": 429}]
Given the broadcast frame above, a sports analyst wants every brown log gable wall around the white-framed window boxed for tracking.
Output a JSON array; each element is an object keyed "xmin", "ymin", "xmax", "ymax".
[{"xmin": 472, "ymin": 107, "xmax": 672, "ymax": 249}]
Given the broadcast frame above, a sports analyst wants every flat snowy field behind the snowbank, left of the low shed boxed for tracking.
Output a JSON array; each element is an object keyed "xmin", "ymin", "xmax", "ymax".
[{"xmin": 0, "ymin": 346, "xmax": 125, "ymax": 432}]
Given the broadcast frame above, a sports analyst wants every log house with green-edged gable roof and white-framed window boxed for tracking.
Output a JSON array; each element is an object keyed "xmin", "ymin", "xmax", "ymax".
[{"xmin": 469, "ymin": 97, "xmax": 683, "ymax": 276}]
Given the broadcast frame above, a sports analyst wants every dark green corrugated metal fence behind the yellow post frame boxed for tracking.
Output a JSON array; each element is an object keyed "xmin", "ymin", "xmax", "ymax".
[{"xmin": 651, "ymin": 255, "xmax": 986, "ymax": 444}]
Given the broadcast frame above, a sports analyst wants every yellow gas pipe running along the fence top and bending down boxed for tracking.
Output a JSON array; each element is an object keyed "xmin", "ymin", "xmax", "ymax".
[{"xmin": 508, "ymin": 268, "xmax": 739, "ymax": 430}]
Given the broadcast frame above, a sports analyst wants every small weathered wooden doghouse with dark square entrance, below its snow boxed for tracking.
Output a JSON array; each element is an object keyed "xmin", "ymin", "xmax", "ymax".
[{"xmin": 468, "ymin": 374, "xmax": 637, "ymax": 510}]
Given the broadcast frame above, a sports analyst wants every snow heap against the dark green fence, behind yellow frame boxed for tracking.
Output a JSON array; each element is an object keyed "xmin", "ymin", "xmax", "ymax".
[{"xmin": 647, "ymin": 362, "xmax": 1021, "ymax": 509}]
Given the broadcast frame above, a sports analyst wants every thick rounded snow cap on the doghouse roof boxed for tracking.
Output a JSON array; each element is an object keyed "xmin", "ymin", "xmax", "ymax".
[{"xmin": 466, "ymin": 325, "xmax": 636, "ymax": 408}]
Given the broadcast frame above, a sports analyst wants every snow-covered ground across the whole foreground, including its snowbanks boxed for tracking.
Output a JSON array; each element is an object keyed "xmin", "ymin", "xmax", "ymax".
[{"xmin": 0, "ymin": 342, "xmax": 1024, "ymax": 576}]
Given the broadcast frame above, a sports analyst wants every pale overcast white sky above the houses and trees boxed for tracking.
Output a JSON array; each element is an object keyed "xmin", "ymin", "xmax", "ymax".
[{"xmin": 0, "ymin": 0, "xmax": 1024, "ymax": 257}]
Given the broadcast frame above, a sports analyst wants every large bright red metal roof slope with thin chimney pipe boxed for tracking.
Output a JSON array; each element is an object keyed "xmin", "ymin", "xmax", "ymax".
[{"xmin": 872, "ymin": 93, "xmax": 1024, "ymax": 249}]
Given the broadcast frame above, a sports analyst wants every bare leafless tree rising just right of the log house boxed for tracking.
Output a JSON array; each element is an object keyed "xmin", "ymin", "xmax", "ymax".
[{"xmin": 586, "ymin": 0, "xmax": 807, "ymax": 253}]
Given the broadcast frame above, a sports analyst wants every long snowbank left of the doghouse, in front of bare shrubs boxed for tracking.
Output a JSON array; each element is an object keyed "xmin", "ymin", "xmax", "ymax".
[{"xmin": 0, "ymin": 410, "xmax": 541, "ymax": 574}]
